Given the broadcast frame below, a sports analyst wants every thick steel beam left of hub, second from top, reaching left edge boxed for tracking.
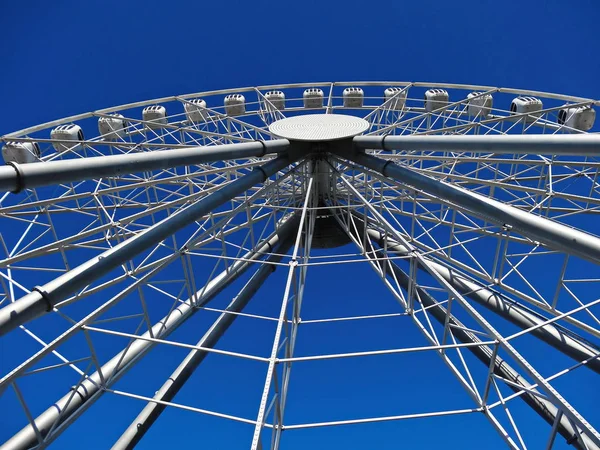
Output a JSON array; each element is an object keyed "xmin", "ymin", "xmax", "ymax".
[{"xmin": 0, "ymin": 156, "xmax": 290, "ymax": 336}]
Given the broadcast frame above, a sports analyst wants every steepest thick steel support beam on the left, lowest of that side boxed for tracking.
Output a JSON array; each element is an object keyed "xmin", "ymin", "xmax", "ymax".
[{"xmin": 112, "ymin": 238, "xmax": 292, "ymax": 450}]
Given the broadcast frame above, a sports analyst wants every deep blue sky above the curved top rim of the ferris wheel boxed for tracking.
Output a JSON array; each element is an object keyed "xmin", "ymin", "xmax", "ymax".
[{"xmin": 0, "ymin": 0, "xmax": 600, "ymax": 132}]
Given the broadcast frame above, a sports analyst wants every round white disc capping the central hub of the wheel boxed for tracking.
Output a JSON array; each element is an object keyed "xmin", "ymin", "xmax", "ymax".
[{"xmin": 269, "ymin": 114, "xmax": 369, "ymax": 142}]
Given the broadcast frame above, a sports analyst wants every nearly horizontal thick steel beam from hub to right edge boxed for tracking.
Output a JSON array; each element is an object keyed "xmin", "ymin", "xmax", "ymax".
[{"xmin": 354, "ymin": 134, "xmax": 600, "ymax": 156}]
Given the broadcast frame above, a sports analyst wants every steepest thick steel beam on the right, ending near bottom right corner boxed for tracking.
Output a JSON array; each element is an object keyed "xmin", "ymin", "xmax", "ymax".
[{"xmin": 344, "ymin": 214, "xmax": 600, "ymax": 450}]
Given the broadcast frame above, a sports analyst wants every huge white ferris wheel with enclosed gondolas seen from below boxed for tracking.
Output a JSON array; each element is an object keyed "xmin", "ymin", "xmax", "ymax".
[{"xmin": 0, "ymin": 82, "xmax": 600, "ymax": 450}]
